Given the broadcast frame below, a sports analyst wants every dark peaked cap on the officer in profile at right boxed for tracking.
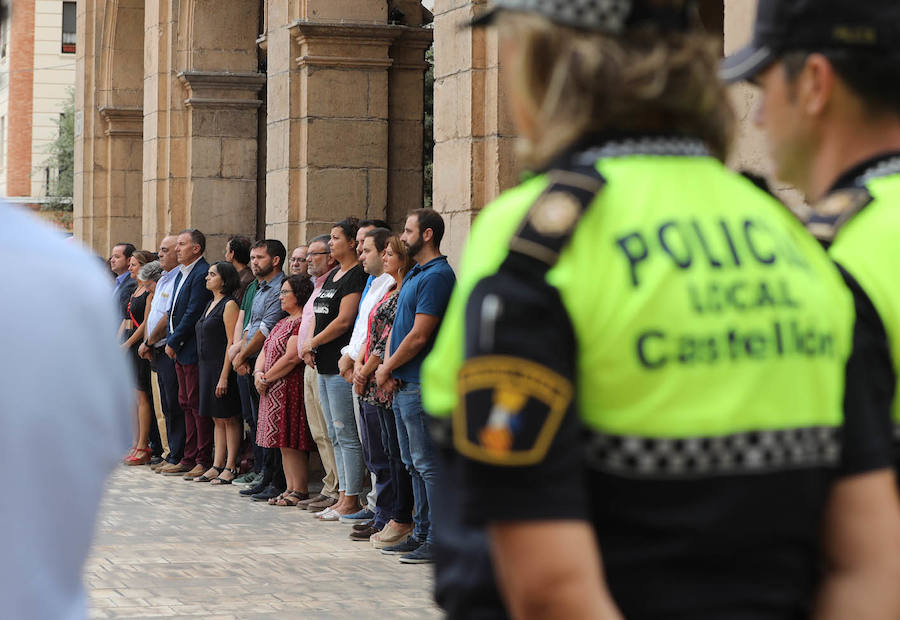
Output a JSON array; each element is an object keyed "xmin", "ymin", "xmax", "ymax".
[{"xmin": 719, "ymin": 0, "xmax": 900, "ymax": 82}]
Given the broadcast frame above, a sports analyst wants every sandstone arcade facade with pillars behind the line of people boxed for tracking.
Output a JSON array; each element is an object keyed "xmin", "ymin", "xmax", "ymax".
[{"xmin": 74, "ymin": 0, "xmax": 764, "ymax": 261}]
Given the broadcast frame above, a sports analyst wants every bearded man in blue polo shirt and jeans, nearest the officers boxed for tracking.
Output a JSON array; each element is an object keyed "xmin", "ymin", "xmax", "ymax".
[{"xmin": 375, "ymin": 209, "xmax": 456, "ymax": 564}]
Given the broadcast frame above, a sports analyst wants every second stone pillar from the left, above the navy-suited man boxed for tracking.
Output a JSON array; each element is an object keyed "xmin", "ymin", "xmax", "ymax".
[{"xmin": 143, "ymin": 0, "xmax": 265, "ymax": 259}]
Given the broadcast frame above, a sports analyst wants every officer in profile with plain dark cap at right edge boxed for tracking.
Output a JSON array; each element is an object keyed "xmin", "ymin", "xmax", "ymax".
[{"xmin": 722, "ymin": 0, "xmax": 900, "ymax": 472}]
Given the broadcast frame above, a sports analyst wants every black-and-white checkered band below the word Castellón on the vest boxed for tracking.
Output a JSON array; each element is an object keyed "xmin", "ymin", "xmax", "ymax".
[{"xmin": 587, "ymin": 427, "xmax": 841, "ymax": 478}]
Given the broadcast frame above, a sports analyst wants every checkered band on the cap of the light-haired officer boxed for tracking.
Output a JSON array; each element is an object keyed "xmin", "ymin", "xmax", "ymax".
[{"xmin": 493, "ymin": 0, "xmax": 632, "ymax": 34}]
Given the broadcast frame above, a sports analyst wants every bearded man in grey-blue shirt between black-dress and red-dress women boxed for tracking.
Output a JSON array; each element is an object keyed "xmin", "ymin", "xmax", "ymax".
[{"xmin": 232, "ymin": 239, "xmax": 287, "ymax": 501}]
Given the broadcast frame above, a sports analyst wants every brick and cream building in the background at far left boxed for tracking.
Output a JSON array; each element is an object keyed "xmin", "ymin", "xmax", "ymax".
[{"xmin": 0, "ymin": 0, "xmax": 77, "ymax": 205}]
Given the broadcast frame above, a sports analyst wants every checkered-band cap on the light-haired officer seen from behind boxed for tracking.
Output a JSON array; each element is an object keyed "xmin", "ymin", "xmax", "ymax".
[{"xmin": 471, "ymin": 0, "xmax": 700, "ymax": 35}]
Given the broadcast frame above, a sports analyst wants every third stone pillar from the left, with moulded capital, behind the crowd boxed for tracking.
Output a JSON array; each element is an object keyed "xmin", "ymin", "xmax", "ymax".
[{"xmin": 266, "ymin": 17, "xmax": 402, "ymax": 246}]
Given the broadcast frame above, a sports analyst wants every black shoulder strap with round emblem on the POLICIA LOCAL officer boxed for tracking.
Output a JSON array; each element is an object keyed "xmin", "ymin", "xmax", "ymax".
[{"xmin": 510, "ymin": 165, "xmax": 606, "ymax": 272}]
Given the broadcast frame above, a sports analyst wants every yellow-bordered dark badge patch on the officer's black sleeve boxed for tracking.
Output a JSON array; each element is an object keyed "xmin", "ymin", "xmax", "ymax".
[{"xmin": 453, "ymin": 355, "xmax": 574, "ymax": 466}]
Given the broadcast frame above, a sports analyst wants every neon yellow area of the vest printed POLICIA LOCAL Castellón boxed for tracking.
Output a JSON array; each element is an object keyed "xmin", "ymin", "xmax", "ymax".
[{"xmin": 422, "ymin": 139, "xmax": 856, "ymax": 461}]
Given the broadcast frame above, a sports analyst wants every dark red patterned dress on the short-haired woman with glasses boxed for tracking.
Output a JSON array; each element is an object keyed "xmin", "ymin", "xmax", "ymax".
[{"xmin": 256, "ymin": 316, "xmax": 312, "ymax": 450}]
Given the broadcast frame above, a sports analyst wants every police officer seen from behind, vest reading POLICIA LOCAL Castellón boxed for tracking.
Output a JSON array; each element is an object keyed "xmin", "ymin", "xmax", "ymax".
[{"xmin": 423, "ymin": 0, "xmax": 900, "ymax": 619}]
